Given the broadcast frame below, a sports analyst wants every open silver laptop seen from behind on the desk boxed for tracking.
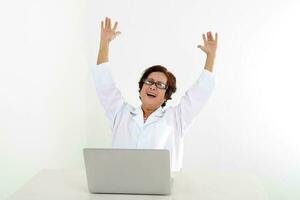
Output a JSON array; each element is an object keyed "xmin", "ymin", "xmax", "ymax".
[{"xmin": 83, "ymin": 148, "xmax": 171, "ymax": 195}]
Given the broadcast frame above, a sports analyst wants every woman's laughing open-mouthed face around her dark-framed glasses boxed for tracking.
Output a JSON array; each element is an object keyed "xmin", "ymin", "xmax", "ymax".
[{"xmin": 140, "ymin": 72, "xmax": 167, "ymax": 110}]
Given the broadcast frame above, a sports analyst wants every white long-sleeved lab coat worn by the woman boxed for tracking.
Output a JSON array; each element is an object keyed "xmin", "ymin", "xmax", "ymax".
[{"xmin": 92, "ymin": 63, "xmax": 214, "ymax": 171}]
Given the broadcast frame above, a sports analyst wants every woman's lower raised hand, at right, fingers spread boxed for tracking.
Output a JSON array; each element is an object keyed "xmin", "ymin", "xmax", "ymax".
[{"xmin": 197, "ymin": 32, "xmax": 218, "ymax": 55}]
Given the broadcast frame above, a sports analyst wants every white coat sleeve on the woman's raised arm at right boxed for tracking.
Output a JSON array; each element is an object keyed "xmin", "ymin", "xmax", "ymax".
[{"xmin": 175, "ymin": 70, "xmax": 215, "ymax": 134}]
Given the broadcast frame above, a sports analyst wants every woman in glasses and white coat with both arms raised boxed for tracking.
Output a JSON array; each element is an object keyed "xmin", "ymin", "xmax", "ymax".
[{"xmin": 92, "ymin": 18, "xmax": 217, "ymax": 171}]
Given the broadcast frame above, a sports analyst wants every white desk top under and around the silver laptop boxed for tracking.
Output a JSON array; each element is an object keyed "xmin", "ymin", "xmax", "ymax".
[{"xmin": 8, "ymin": 170, "xmax": 268, "ymax": 200}]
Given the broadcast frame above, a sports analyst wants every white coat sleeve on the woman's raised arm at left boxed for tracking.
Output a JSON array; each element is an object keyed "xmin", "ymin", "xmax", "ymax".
[{"xmin": 91, "ymin": 63, "xmax": 124, "ymax": 128}]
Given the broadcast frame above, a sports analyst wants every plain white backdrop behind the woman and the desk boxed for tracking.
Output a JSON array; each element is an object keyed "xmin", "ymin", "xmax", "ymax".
[{"xmin": 0, "ymin": 0, "xmax": 300, "ymax": 199}]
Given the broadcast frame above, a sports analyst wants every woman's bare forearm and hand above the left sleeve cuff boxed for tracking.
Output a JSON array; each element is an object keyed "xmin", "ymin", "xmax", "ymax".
[{"xmin": 97, "ymin": 17, "xmax": 121, "ymax": 65}]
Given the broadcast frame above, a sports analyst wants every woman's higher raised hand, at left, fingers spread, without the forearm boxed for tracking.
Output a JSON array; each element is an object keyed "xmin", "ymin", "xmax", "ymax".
[{"xmin": 101, "ymin": 17, "xmax": 121, "ymax": 44}]
